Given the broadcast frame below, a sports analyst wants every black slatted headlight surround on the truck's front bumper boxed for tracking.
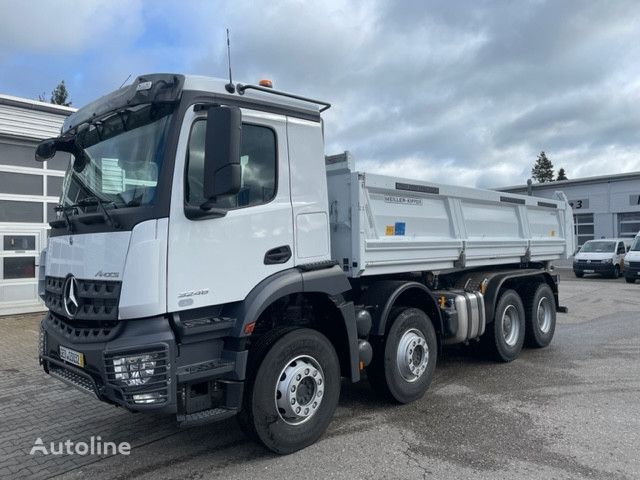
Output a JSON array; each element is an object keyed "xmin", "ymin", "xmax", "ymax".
[{"xmin": 104, "ymin": 346, "xmax": 171, "ymax": 407}]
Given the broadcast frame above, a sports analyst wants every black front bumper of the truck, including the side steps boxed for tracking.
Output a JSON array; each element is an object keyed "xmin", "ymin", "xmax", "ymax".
[{"xmin": 39, "ymin": 312, "xmax": 247, "ymax": 414}]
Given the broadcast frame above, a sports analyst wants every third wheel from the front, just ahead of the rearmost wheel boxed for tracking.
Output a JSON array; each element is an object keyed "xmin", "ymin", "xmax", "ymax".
[{"xmin": 483, "ymin": 290, "xmax": 525, "ymax": 362}]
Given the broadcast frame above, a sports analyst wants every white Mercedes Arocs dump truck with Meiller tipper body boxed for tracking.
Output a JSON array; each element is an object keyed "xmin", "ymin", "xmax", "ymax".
[{"xmin": 36, "ymin": 74, "xmax": 574, "ymax": 453}]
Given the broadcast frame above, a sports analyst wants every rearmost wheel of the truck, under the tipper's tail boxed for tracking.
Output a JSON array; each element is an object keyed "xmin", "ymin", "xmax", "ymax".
[{"xmin": 525, "ymin": 283, "xmax": 556, "ymax": 348}]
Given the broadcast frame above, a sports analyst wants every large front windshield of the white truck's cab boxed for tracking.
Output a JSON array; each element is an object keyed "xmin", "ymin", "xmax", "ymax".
[{"xmin": 62, "ymin": 104, "xmax": 174, "ymax": 208}]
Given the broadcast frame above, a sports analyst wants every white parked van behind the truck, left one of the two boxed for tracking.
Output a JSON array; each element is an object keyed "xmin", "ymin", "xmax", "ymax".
[{"xmin": 573, "ymin": 238, "xmax": 631, "ymax": 278}]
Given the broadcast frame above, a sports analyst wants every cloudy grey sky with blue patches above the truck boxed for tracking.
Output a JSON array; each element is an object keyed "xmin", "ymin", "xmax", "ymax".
[{"xmin": 0, "ymin": 0, "xmax": 640, "ymax": 187}]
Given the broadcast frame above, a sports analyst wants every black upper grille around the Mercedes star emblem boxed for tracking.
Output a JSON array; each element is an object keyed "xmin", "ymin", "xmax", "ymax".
[{"xmin": 44, "ymin": 277, "xmax": 122, "ymax": 320}]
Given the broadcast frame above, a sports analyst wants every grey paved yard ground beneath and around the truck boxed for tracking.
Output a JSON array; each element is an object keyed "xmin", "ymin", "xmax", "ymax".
[{"xmin": 0, "ymin": 270, "xmax": 640, "ymax": 480}]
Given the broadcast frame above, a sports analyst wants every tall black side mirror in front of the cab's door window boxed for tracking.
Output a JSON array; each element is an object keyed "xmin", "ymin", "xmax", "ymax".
[{"xmin": 203, "ymin": 106, "xmax": 242, "ymax": 201}]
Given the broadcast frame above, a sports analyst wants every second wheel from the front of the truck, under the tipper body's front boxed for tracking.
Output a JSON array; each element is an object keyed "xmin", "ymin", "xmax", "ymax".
[{"xmin": 367, "ymin": 308, "xmax": 438, "ymax": 404}]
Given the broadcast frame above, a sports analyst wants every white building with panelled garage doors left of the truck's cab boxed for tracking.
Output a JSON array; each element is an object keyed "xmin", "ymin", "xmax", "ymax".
[{"xmin": 0, "ymin": 95, "xmax": 75, "ymax": 315}]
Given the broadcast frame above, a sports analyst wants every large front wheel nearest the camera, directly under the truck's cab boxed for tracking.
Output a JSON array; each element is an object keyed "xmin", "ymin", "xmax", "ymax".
[{"xmin": 238, "ymin": 328, "xmax": 341, "ymax": 454}]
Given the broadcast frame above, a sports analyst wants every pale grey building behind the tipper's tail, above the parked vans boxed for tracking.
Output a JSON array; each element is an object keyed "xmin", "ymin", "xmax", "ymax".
[{"xmin": 497, "ymin": 172, "xmax": 640, "ymax": 245}]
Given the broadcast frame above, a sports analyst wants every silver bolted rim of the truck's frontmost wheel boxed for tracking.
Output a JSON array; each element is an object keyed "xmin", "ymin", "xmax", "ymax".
[{"xmin": 275, "ymin": 355, "xmax": 325, "ymax": 425}]
